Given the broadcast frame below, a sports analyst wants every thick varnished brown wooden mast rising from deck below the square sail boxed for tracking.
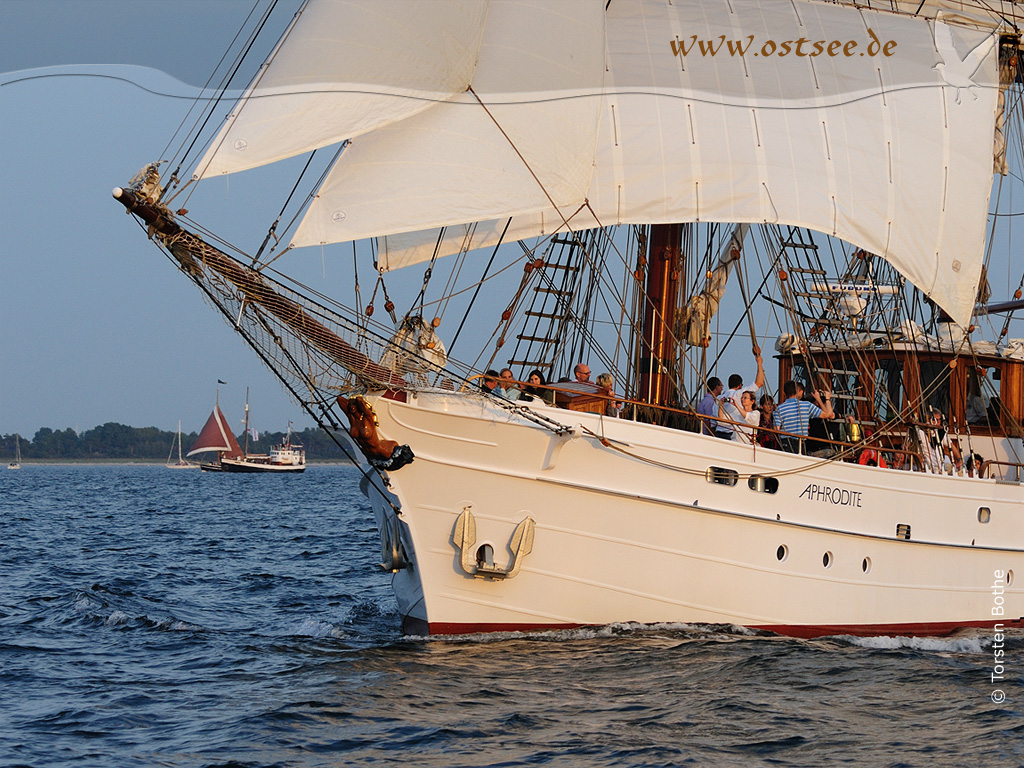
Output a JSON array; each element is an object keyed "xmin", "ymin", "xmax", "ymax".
[{"xmin": 639, "ymin": 224, "xmax": 683, "ymax": 406}]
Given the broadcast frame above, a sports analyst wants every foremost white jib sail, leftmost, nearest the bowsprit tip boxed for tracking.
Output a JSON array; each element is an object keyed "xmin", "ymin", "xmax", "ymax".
[{"xmin": 195, "ymin": 0, "xmax": 488, "ymax": 178}]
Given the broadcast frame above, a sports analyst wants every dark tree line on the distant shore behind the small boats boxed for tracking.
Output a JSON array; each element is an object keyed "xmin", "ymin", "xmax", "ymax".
[{"xmin": 0, "ymin": 422, "xmax": 347, "ymax": 462}]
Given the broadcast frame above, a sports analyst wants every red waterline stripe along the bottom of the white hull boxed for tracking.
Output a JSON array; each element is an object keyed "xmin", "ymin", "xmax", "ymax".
[{"xmin": 411, "ymin": 616, "xmax": 1024, "ymax": 638}]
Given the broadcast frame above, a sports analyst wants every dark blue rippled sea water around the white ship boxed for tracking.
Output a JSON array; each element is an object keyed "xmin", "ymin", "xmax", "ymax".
[{"xmin": 0, "ymin": 464, "xmax": 1024, "ymax": 768}]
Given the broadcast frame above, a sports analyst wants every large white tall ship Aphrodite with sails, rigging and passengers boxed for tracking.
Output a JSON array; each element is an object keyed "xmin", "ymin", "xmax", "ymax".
[{"xmin": 114, "ymin": 0, "xmax": 1024, "ymax": 637}]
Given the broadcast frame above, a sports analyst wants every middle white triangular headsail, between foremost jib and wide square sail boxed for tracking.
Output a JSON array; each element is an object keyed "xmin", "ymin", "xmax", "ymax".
[{"xmin": 292, "ymin": 0, "xmax": 604, "ymax": 246}]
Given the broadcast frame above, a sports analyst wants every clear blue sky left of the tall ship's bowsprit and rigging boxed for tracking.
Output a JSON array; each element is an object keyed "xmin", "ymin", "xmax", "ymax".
[{"xmin": 0, "ymin": 0, "xmax": 318, "ymax": 437}]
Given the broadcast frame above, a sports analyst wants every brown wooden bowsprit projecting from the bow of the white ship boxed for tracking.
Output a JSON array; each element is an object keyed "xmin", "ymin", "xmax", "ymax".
[{"xmin": 114, "ymin": 187, "xmax": 406, "ymax": 389}]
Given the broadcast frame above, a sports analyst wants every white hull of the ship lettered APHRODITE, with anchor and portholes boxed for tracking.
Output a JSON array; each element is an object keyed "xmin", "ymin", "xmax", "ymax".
[{"xmin": 346, "ymin": 393, "xmax": 1024, "ymax": 637}]
